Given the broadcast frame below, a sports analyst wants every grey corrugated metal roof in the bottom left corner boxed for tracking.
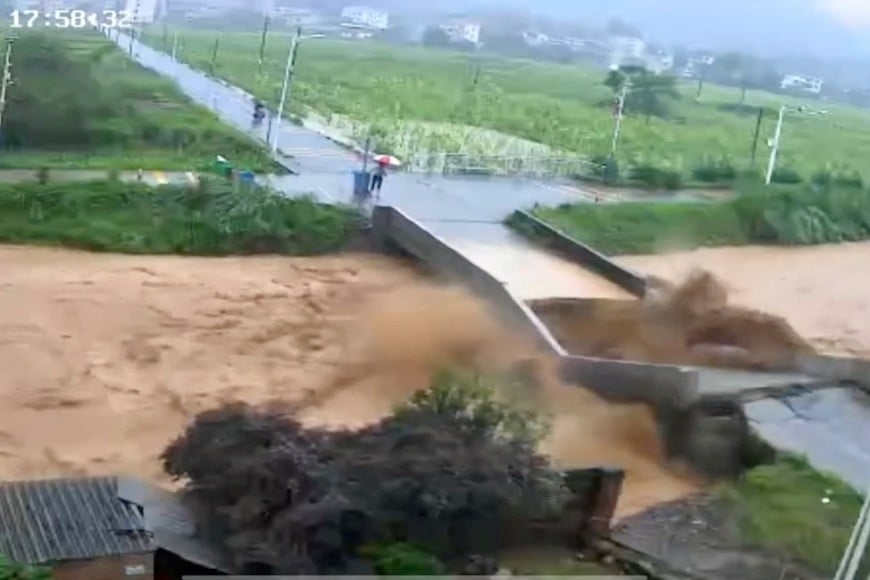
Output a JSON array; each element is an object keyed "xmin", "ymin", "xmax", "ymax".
[{"xmin": 0, "ymin": 477, "xmax": 155, "ymax": 564}]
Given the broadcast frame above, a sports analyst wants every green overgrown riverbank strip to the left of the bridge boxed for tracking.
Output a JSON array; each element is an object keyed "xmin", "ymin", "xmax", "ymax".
[{"xmin": 0, "ymin": 180, "xmax": 358, "ymax": 255}]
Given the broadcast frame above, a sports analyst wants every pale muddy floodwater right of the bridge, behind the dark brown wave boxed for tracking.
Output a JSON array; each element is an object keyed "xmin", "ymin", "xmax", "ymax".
[{"xmin": 617, "ymin": 242, "xmax": 870, "ymax": 357}]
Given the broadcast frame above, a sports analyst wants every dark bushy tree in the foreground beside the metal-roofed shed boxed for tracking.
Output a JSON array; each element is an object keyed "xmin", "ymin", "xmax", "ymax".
[{"xmin": 163, "ymin": 372, "xmax": 566, "ymax": 574}]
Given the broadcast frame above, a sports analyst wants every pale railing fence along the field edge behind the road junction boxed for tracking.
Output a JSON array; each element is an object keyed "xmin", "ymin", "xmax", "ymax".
[{"xmin": 402, "ymin": 152, "xmax": 603, "ymax": 179}]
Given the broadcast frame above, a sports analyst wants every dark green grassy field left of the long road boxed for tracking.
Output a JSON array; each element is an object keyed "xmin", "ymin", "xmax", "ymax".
[{"xmin": 0, "ymin": 31, "xmax": 271, "ymax": 171}]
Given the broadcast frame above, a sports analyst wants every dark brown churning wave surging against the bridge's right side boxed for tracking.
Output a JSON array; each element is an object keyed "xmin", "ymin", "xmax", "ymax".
[{"xmin": 533, "ymin": 271, "xmax": 813, "ymax": 370}]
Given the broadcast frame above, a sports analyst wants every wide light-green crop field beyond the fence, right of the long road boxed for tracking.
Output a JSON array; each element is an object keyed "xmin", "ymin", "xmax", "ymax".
[{"xmin": 146, "ymin": 30, "xmax": 870, "ymax": 182}]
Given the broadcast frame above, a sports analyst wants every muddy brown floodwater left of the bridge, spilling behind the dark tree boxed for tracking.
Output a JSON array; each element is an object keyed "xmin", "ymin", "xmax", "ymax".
[{"xmin": 0, "ymin": 246, "xmax": 697, "ymax": 515}]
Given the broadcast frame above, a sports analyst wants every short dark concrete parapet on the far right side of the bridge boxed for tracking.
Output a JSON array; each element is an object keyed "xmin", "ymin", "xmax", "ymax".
[{"xmin": 508, "ymin": 210, "xmax": 647, "ymax": 297}]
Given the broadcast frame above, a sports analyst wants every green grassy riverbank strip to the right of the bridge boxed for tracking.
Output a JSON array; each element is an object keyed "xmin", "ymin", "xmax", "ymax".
[{"xmin": 520, "ymin": 183, "xmax": 870, "ymax": 255}]
